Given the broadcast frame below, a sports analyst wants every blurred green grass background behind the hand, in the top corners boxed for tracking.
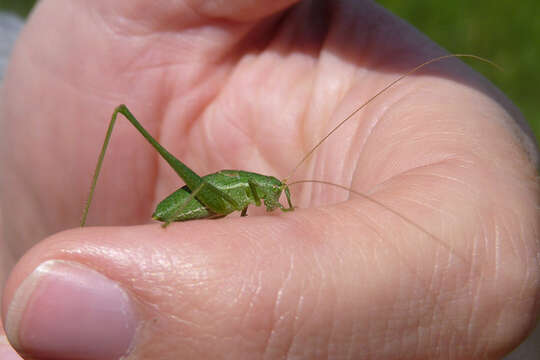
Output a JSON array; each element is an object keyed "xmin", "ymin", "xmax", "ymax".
[{"xmin": 0, "ymin": 0, "xmax": 540, "ymax": 143}]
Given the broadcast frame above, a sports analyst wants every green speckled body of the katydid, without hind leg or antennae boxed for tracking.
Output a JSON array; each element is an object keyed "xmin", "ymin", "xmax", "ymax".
[{"xmin": 152, "ymin": 170, "xmax": 282, "ymax": 222}]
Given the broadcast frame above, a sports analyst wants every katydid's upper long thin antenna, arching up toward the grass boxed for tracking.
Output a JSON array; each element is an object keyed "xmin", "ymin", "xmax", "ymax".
[{"xmin": 282, "ymin": 54, "xmax": 504, "ymax": 183}]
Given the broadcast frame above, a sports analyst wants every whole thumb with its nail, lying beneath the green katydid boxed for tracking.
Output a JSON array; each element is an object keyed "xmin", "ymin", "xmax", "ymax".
[{"xmin": 2, "ymin": 194, "xmax": 537, "ymax": 360}]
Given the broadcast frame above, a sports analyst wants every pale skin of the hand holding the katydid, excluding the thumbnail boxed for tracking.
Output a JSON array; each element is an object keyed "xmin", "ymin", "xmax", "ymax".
[{"xmin": 0, "ymin": 0, "xmax": 540, "ymax": 359}]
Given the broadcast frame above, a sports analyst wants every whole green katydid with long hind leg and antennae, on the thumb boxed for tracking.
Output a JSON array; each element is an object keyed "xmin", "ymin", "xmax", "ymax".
[{"xmin": 81, "ymin": 54, "xmax": 499, "ymax": 227}]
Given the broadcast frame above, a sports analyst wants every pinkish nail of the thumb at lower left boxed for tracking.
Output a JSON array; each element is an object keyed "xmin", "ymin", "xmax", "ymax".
[{"xmin": 6, "ymin": 260, "xmax": 137, "ymax": 360}]
